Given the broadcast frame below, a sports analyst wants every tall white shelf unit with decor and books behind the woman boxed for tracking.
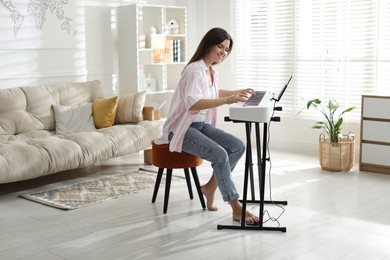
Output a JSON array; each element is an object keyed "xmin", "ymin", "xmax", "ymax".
[{"xmin": 117, "ymin": 4, "xmax": 187, "ymax": 95}]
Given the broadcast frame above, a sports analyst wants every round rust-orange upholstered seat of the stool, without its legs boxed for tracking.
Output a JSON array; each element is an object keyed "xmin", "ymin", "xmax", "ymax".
[{"xmin": 152, "ymin": 142, "xmax": 203, "ymax": 169}]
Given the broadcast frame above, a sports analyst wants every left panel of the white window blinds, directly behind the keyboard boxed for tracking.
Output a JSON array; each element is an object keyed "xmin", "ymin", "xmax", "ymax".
[{"xmin": 233, "ymin": 0, "xmax": 294, "ymax": 112}]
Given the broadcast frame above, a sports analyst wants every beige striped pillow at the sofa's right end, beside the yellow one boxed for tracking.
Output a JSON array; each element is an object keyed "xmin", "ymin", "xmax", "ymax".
[{"xmin": 116, "ymin": 91, "xmax": 146, "ymax": 123}]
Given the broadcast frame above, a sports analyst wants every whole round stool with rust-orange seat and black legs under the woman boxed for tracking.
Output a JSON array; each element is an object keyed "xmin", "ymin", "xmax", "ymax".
[{"xmin": 152, "ymin": 142, "xmax": 206, "ymax": 214}]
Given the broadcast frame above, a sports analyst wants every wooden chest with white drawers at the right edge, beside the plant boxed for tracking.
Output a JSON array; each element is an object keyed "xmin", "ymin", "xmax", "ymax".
[{"xmin": 359, "ymin": 95, "xmax": 390, "ymax": 174}]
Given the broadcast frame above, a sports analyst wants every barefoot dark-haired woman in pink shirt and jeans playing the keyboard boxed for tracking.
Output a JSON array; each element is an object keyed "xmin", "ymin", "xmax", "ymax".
[{"xmin": 156, "ymin": 28, "xmax": 259, "ymax": 224}]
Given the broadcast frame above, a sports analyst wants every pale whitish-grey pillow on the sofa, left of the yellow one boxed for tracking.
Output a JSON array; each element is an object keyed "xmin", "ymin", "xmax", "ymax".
[{"xmin": 53, "ymin": 103, "xmax": 96, "ymax": 134}]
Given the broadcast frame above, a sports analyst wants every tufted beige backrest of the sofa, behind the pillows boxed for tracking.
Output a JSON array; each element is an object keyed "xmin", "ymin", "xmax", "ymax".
[{"xmin": 0, "ymin": 80, "xmax": 104, "ymax": 135}]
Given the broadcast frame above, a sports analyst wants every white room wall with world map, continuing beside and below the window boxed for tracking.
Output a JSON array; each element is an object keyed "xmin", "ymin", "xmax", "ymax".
[{"xmin": 0, "ymin": 0, "xmax": 360, "ymax": 158}]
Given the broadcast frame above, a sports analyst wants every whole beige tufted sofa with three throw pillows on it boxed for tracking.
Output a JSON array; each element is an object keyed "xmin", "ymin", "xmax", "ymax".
[{"xmin": 0, "ymin": 80, "xmax": 163, "ymax": 183}]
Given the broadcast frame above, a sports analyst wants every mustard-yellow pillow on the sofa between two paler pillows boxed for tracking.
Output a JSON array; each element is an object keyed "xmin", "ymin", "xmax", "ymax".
[{"xmin": 92, "ymin": 96, "xmax": 118, "ymax": 128}]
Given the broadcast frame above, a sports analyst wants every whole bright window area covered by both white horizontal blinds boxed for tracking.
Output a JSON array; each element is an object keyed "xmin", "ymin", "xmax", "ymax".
[{"xmin": 233, "ymin": 0, "xmax": 390, "ymax": 122}]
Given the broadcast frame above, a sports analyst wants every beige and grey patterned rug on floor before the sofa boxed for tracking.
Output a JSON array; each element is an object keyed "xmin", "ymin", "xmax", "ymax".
[{"xmin": 21, "ymin": 168, "xmax": 180, "ymax": 210}]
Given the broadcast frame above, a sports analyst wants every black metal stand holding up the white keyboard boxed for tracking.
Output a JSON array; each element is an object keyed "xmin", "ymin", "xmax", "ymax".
[{"xmin": 217, "ymin": 117, "xmax": 287, "ymax": 232}]
